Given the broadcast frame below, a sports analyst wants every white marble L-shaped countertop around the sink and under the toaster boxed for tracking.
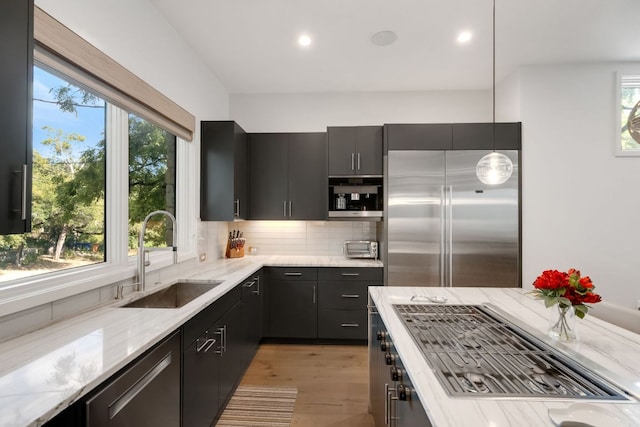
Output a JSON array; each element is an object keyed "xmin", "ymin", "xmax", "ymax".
[{"xmin": 0, "ymin": 256, "xmax": 382, "ymax": 427}]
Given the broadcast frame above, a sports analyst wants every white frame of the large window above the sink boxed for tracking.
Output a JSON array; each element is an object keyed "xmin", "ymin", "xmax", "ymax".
[{"xmin": 0, "ymin": 13, "xmax": 197, "ymax": 317}]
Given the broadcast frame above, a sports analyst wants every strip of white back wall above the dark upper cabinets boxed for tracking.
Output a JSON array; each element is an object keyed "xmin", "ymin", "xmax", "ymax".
[{"xmin": 229, "ymin": 91, "xmax": 491, "ymax": 132}]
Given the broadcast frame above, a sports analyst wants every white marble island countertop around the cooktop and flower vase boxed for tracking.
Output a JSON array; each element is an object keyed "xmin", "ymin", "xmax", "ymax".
[{"xmin": 369, "ymin": 287, "xmax": 640, "ymax": 427}]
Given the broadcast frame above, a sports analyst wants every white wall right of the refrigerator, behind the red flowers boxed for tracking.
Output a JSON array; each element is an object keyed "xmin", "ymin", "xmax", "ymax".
[{"xmin": 519, "ymin": 63, "xmax": 640, "ymax": 308}]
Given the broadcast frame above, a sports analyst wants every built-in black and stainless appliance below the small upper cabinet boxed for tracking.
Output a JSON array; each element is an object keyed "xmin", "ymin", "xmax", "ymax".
[{"xmin": 329, "ymin": 177, "xmax": 383, "ymax": 220}]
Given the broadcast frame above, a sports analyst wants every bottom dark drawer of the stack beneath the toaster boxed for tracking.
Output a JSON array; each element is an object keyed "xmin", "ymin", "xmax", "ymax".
[{"xmin": 318, "ymin": 310, "xmax": 367, "ymax": 340}]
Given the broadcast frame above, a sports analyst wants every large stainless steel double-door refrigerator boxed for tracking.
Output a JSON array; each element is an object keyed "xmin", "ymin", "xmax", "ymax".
[{"xmin": 383, "ymin": 150, "xmax": 521, "ymax": 287}]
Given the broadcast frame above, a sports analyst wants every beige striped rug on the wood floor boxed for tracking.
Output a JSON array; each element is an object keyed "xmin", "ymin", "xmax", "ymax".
[{"xmin": 216, "ymin": 386, "xmax": 298, "ymax": 427}]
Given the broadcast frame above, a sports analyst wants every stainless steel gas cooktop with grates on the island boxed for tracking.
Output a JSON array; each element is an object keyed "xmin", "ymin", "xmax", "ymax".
[{"xmin": 394, "ymin": 304, "xmax": 633, "ymax": 401}]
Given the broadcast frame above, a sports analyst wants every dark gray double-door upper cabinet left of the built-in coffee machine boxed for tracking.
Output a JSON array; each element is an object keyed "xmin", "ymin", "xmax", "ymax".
[{"xmin": 249, "ymin": 132, "xmax": 328, "ymax": 220}]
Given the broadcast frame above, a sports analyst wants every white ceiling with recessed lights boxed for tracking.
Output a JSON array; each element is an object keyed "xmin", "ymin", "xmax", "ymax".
[{"xmin": 150, "ymin": 0, "xmax": 640, "ymax": 93}]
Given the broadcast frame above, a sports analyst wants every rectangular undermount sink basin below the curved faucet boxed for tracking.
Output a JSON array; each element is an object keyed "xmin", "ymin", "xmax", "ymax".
[{"xmin": 122, "ymin": 280, "xmax": 222, "ymax": 308}]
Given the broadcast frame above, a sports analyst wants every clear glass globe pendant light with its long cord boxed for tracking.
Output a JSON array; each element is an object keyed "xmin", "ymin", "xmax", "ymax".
[{"xmin": 476, "ymin": 0, "xmax": 513, "ymax": 185}]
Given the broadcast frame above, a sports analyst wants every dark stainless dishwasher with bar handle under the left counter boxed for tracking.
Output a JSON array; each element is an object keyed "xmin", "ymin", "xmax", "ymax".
[{"xmin": 86, "ymin": 331, "xmax": 181, "ymax": 427}]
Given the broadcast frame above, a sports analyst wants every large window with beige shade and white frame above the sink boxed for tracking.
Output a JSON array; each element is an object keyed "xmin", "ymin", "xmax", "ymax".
[{"xmin": 0, "ymin": 7, "xmax": 197, "ymax": 316}]
